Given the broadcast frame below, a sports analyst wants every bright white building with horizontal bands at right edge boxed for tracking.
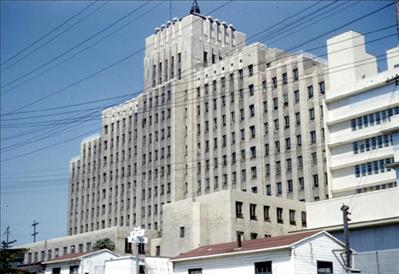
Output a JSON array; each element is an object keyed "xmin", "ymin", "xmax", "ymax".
[{"xmin": 324, "ymin": 31, "xmax": 399, "ymax": 197}]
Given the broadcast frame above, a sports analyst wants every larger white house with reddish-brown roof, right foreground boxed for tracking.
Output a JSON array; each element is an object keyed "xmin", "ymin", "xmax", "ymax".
[{"xmin": 172, "ymin": 231, "xmax": 354, "ymax": 274}]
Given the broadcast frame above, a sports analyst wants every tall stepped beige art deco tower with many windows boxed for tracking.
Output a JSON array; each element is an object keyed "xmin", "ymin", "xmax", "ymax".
[{"xmin": 68, "ymin": 5, "xmax": 328, "ymax": 239}]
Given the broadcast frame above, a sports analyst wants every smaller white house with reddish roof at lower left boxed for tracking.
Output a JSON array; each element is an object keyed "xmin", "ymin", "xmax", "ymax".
[{"xmin": 43, "ymin": 249, "xmax": 119, "ymax": 274}]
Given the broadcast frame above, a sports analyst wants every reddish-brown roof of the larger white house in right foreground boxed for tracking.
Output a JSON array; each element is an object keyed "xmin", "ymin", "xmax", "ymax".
[{"xmin": 172, "ymin": 231, "xmax": 328, "ymax": 261}]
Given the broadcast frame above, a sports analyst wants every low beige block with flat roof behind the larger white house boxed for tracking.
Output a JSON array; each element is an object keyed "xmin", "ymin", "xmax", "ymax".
[{"xmin": 157, "ymin": 190, "xmax": 306, "ymax": 257}]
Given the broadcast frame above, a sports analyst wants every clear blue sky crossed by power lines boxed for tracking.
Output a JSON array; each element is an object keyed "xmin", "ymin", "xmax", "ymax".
[{"xmin": 0, "ymin": 0, "xmax": 397, "ymax": 244}]
